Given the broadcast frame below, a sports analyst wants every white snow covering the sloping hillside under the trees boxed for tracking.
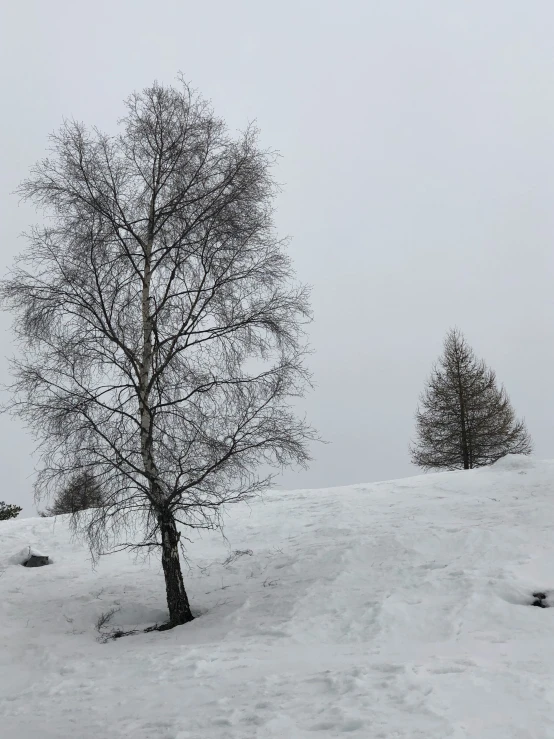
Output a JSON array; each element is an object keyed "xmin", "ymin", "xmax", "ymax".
[{"xmin": 0, "ymin": 458, "xmax": 554, "ymax": 739}]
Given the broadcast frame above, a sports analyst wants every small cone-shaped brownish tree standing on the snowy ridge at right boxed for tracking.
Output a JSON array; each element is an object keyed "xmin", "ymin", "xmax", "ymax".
[{"xmin": 411, "ymin": 329, "xmax": 532, "ymax": 470}]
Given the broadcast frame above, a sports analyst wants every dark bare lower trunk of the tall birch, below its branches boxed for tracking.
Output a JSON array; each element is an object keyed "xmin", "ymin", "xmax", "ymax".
[{"xmin": 158, "ymin": 512, "xmax": 194, "ymax": 627}]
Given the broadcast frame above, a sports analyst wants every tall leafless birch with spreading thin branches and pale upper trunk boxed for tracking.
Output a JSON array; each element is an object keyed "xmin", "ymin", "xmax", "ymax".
[{"xmin": 1, "ymin": 83, "xmax": 314, "ymax": 626}]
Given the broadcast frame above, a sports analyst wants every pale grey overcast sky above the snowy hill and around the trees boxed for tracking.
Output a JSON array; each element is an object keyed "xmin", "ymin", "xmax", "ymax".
[{"xmin": 0, "ymin": 0, "xmax": 554, "ymax": 515}]
